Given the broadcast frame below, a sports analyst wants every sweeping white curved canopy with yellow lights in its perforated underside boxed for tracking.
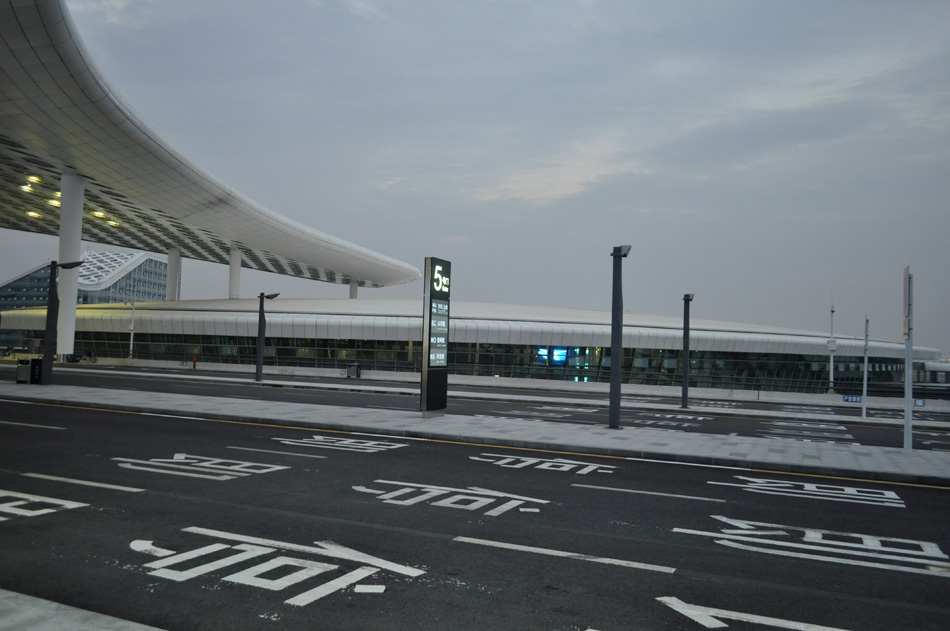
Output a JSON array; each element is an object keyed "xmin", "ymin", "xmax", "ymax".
[{"xmin": 0, "ymin": 0, "xmax": 420, "ymax": 287}]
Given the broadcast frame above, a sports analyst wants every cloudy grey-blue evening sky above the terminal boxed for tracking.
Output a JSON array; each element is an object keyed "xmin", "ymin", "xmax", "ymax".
[{"xmin": 0, "ymin": 0, "xmax": 950, "ymax": 357}]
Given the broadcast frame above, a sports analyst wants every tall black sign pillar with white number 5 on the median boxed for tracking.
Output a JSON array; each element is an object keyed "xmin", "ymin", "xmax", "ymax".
[{"xmin": 419, "ymin": 257, "xmax": 452, "ymax": 412}]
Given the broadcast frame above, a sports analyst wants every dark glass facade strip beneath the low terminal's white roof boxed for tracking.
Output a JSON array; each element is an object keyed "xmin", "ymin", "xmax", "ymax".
[{"xmin": 11, "ymin": 331, "xmax": 904, "ymax": 392}]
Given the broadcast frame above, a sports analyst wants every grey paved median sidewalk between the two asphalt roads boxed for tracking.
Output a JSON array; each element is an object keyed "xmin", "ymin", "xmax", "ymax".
[{"xmin": 0, "ymin": 375, "xmax": 950, "ymax": 486}]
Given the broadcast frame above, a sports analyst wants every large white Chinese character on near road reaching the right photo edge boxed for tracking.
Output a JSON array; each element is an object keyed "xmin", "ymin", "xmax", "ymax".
[{"xmin": 673, "ymin": 515, "xmax": 950, "ymax": 577}]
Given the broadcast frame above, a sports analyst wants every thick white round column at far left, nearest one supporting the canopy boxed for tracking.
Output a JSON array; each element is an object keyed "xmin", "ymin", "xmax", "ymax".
[{"xmin": 56, "ymin": 171, "xmax": 86, "ymax": 355}]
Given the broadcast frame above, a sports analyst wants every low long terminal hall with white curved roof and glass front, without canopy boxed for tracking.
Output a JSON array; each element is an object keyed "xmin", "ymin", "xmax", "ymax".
[{"xmin": 2, "ymin": 298, "xmax": 939, "ymax": 393}]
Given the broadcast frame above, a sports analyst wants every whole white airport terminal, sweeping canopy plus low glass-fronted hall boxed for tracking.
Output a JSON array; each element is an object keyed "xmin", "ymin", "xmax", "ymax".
[{"xmin": 0, "ymin": 0, "xmax": 939, "ymax": 392}]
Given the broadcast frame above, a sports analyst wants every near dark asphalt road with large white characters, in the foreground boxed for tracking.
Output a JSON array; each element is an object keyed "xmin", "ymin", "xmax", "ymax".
[{"xmin": 0, "ymin": 392, "xmax": 950, "ymax": 631}]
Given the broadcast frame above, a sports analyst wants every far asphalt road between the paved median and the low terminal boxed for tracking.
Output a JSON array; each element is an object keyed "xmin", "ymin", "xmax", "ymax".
[{"xmin": 9, "ymin": 368, "xmax": 950, "ymax": 450}]
